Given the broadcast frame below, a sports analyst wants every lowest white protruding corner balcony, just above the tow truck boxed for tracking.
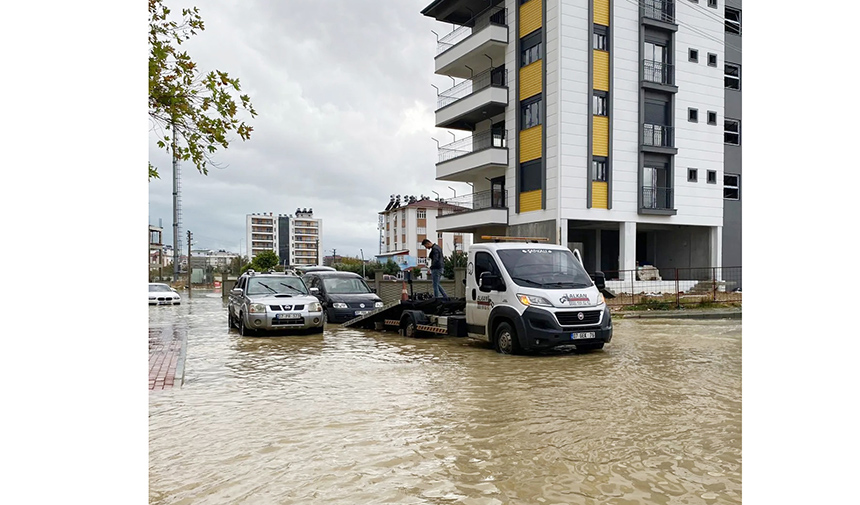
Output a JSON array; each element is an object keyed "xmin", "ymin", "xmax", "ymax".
[{"xmin": 436, "ymin": 190, "xmax": 508, "ymax": 233}]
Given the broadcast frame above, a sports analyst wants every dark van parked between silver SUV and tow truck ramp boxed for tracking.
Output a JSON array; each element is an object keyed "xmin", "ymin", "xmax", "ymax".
[{"xmin": 302, "ymin": 271, "xmax": 383, "ymax": 323}]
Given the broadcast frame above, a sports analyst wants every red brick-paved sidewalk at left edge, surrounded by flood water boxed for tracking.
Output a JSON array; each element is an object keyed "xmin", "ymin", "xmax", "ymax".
[{"xmin": 149, "ymin": 326, "xmax": 186, "ymax": 391}]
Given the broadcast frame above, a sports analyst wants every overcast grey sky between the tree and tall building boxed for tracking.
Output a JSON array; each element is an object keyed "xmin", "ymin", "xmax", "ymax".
[{"xmin": 149, "ymin": 0, "xmax": 469, "ymax": 257}]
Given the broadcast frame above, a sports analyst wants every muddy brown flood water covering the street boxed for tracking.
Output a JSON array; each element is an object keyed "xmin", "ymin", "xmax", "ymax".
[{"xmin": 149, "ymin": 292, "xmax": 741, "ymax": 505}]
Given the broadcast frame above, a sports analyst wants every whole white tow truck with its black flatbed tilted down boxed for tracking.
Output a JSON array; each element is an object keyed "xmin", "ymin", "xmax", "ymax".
[{"xmin": 343, "ymin": 236, "xmax": 612, "ymax": 354}]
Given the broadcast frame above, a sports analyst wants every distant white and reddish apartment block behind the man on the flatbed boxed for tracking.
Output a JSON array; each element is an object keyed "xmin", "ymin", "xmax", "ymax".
[{"xmin": 377, "ymin": 195, "xmax": 472, "ymax": 266}]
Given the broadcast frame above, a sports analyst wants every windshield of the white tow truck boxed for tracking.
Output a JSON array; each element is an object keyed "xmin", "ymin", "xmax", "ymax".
[{"xmin": 498, "ymin": 249, "xmax": 593, "ymax": 288}]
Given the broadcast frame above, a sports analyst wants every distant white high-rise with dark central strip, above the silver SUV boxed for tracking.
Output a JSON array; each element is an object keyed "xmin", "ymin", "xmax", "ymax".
[{"xmin": 245, "ymin": 209, "xmax": 323, "ymax": 265}]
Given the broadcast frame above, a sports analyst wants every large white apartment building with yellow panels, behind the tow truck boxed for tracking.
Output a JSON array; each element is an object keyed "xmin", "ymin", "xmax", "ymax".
[{"xmin": 422, "ymin": 0, "xmax": 740, "ymax": 278}]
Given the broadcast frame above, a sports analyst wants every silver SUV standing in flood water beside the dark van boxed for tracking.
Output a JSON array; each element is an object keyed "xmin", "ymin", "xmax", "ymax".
[{"xmin": 227, "ymin": 270, "xmax": 325, "ymax": 336}]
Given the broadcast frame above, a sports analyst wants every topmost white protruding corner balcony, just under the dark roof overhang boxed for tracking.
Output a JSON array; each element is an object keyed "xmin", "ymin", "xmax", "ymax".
[{"xmin": 436, "ymin": 6, "xmax": 508, "ymax": 79}]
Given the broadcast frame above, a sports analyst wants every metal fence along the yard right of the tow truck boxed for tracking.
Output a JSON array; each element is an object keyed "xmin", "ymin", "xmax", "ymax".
[{"xmin": 603, "ymin": 267, "xmax": 742, "ymax": 309}]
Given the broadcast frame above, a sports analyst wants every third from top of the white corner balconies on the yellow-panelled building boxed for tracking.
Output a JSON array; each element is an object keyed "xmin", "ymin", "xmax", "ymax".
[{"xmin": 436, "ymin": 130, "xmax": 508, "ymax": 182}]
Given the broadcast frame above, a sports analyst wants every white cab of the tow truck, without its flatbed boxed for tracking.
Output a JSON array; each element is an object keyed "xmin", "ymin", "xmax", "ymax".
[{"xmin": 465, "ymin": 241, "xmax": 612, "ymax": 354}]
